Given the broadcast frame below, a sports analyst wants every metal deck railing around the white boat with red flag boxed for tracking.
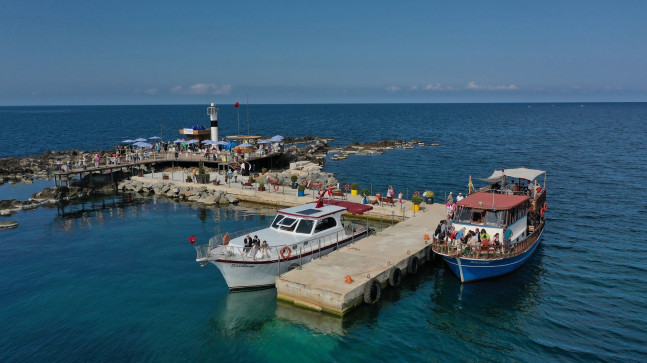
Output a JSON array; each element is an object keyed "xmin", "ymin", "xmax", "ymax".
[{"xmin": 194, "ymin": 224, "xmax": 366, "ymax": 264}]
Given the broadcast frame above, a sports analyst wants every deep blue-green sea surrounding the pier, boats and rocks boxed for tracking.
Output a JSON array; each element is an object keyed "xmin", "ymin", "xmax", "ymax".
[{"xmin": 0, "ymin": 103, "xmax": 647, "ymax": 362}]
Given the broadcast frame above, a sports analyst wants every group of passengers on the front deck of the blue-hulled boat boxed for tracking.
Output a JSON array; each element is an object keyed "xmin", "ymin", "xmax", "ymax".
[{"xmin": 434, "ymin": 219, "xmax": 512, "ymax": 253}]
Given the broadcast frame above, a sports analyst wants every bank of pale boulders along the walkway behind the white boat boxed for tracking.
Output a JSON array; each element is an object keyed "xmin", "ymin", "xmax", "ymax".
[{"xmin": 117, "ymin": 180, "xmax": 238, "ymax": 204}]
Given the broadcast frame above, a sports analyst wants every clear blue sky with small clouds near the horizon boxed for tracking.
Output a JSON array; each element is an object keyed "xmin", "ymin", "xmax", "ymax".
[{"xmin": 0, "ymin": 0, "xmax": 647, "ymax": 106}]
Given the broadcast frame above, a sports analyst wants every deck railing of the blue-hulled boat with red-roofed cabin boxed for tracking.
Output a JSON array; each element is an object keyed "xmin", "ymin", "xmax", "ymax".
[{"xmin": 431, "ymin": 222, "xmax": 544, "ymax": 260}]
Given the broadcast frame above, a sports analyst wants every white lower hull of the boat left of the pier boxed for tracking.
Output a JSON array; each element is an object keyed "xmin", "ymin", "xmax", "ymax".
[{"xmin": 209, "ymin": 231, "xmax": 367, "ymax": 291}]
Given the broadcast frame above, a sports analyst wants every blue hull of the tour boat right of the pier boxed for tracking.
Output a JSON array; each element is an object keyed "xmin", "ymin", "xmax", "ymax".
[{"xmin": 441, "ymin": 230, "xmax": 543, "ymax": 282}]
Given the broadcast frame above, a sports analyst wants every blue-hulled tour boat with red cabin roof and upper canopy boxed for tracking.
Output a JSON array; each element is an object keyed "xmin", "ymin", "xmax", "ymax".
[{"xmin": 432, "ymin": 168, "xmax": 547, "ymax": 282}]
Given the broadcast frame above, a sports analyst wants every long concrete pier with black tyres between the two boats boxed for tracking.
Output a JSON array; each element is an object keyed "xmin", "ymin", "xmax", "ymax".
[{"xmin": 276, "ymin": 204, "xmax": 446, "ymax": 316}]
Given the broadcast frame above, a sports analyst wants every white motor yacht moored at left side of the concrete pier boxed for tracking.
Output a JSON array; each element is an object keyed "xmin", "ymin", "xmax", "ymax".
[{"xmin": 195, "ymin": 199, "xmax": 372, "ymax": 290}]
